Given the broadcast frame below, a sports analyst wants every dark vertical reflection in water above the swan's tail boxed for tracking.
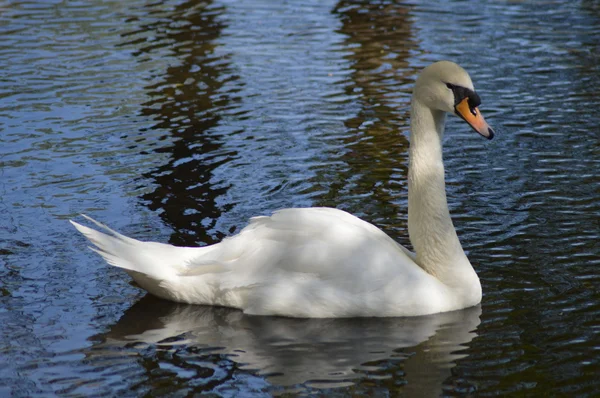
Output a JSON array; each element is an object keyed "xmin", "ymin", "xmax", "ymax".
[{"xmin": 127, "ymin": 0, "xmax": 235, "ymax": 246}]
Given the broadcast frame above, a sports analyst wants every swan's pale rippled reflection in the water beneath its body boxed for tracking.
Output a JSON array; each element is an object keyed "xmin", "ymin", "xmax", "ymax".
[{"xmin": 85, "ymin": 296, "xmax": 481, "ymax": 396}]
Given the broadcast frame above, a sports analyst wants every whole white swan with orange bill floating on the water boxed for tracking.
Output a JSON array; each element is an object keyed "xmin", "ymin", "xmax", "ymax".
[{"xmin": 71, "ymin": 61, "xmax": 493, "ymax": 318}]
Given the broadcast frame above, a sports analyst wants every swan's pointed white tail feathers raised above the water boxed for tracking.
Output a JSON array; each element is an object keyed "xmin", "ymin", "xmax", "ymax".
[{"xmin": 70, "ymin": 215, "xmax": 206, "ymax": 281}]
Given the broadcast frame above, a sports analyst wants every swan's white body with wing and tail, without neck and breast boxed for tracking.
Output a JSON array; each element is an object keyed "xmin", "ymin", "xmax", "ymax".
[{"xmin": 74, "ymin": 208, "xmax": 440, "ymax": 317}]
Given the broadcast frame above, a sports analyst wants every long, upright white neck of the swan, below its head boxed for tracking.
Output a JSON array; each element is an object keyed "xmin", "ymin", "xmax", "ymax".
[{"xmin": 408, "ymin": 98, "xmax": 472, "ymax": 284}]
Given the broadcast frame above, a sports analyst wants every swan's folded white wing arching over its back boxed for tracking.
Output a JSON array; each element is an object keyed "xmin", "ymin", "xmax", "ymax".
[{"xmin": 181, "ymin": 208, "xmax": 418, "ymax": 282}]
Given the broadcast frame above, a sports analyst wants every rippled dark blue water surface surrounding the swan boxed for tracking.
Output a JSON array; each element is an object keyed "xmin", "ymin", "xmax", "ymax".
[{"xmin": 0, "ymin": 0, "xmax": 600, "ymax": 397}]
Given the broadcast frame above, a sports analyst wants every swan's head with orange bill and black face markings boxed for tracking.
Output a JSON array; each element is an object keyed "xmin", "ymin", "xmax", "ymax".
[{"xmin": 413, "ymin": 61, "xmax": 494, "ymax": 140}]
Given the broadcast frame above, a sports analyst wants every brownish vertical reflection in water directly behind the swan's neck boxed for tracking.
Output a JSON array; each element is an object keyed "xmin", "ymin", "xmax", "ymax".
[{"xmin": 321, "ymin": 1, "xmax": 417, "ymax": 243}]
